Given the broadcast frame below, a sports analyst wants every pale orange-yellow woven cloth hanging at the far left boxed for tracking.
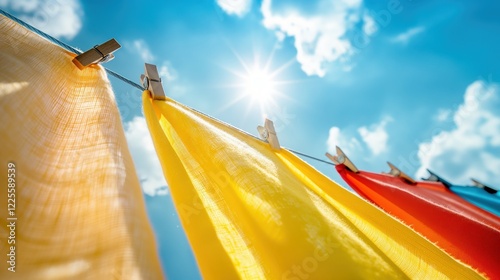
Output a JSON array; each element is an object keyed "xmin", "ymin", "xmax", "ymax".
[{"xmin": 0, "ymin": 16, "xmax": 163, "ymax": 279}]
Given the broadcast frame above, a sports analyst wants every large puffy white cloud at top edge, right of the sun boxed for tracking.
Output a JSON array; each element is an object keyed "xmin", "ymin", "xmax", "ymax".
[{"xmin": 261, "ymin": 0, "xmax": 377, "ymax": 77}]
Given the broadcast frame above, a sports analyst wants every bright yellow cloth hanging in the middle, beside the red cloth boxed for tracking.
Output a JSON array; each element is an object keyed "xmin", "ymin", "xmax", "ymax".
[{"xmin": 143, "ymin": 91, "xmax": 481, "ymax": 280}]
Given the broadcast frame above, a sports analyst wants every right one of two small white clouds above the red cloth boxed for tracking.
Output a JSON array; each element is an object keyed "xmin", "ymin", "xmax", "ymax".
[{"xmin": 358, "ymin": 117, "xmax": 392, "ymax": 156}]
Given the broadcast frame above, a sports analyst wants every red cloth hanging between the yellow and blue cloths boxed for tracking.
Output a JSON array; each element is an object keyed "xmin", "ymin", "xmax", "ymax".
[{"xmin": 336, "ymin": 164, "xmax": 500, "ymax": 279}]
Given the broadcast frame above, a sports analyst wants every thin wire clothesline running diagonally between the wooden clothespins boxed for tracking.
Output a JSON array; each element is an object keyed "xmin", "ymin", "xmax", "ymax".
[{"xmin": 0, "ymin": 9, "xmax": 335, "ymax": 165}]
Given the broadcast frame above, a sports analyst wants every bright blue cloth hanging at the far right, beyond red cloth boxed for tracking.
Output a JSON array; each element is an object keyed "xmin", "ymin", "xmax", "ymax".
[{"xmin": 425, "ymin": 170, "xmax": 500, "ymax": 217}]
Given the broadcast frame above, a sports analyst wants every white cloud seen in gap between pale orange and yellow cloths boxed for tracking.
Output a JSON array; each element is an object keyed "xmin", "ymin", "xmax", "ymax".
[{"xmin": 125, "ymin": 117, "xmax": 167, "ymax": 195}]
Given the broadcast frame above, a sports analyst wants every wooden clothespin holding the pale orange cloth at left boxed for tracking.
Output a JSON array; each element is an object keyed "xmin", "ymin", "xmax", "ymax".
[{"xmin": 73, "ymin": 39, "xmax": 121, "ymax": 70}]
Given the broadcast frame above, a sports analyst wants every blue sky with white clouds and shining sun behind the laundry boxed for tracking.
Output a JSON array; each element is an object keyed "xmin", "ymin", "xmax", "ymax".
[{"xmin": 0, "ymin": 0, "xmax": 500, "ymax": 279}]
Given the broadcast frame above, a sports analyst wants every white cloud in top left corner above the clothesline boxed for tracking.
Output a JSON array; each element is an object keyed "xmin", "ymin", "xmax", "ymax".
[{"xmin": 0, "ymin": 0, "xmax": 83, "ymax": 39}]
